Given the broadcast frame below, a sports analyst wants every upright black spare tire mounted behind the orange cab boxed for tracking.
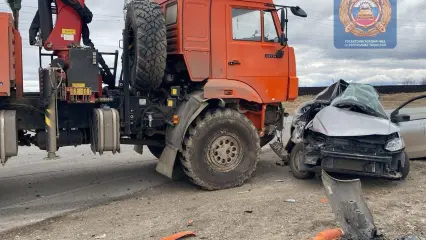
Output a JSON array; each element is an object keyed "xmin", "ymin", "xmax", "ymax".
[{"xmin": 124, "ymin": 0, "xmax": 167, "ymax": 91}]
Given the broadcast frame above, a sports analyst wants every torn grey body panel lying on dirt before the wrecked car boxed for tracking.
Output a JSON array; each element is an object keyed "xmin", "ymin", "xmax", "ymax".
[{"xmin": 322, "ymin": 170, "xmax": 378, "ymax": 239}]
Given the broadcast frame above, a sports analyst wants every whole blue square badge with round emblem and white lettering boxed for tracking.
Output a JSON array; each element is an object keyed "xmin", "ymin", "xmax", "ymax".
[{"xmin": 334, "ymin": 0, "xmax": 397, "ymax": 49}]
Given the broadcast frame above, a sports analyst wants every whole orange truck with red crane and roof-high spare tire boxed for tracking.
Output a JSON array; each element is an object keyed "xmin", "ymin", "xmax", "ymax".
[{"xmin": 0, "ymin": 0, "xmax": 307, "ymax": 190}]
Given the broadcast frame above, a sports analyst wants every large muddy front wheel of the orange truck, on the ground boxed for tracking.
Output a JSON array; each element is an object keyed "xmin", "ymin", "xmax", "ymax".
[{"xmin": 181, "ymin": 109, "xmax": 260, "ymax": 190}]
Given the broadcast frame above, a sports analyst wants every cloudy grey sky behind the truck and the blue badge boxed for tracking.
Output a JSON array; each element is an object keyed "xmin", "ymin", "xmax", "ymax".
[{"xmin": 0, "ymin": 0, "xmax": 426, "ymax": 91}]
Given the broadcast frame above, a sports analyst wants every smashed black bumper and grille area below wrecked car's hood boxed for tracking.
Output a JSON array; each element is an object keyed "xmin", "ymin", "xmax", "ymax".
[{"xmin": 304, "ymin": 131, "xmax": 406, "ymax": 179}]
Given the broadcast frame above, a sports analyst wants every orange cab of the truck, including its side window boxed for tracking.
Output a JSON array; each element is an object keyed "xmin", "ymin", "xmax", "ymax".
[{"xmin": 154, "ymin": 0, "xmax": 299, "ymax": 130}]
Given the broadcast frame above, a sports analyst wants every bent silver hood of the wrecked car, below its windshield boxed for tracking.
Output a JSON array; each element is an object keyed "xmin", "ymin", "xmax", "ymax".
[{"xmin": 311, "ymin": 106, "xmax": 399, "ymax": 137}]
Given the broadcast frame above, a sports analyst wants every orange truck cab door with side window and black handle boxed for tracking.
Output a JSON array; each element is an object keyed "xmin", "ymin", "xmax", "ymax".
[{"xmin": 226, "ymin": 1, "xmax": 289, "ymax": 103}]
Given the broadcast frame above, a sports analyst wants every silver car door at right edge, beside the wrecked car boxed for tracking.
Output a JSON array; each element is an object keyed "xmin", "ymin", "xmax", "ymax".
[{"xmin": 391, "ymin": 95, "xmax": 426, "ymax": 158}]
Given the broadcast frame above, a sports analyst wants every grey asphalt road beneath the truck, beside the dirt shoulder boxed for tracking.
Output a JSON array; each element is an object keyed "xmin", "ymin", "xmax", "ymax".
[{"xmin": 0, "ymin": 117, "xmax": 291, "ymax": 232}]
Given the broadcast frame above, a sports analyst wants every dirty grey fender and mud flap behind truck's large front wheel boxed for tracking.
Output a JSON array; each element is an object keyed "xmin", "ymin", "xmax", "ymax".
[{"xmin": 156, "ymin": 92, "xmax": 208, "ymax": 180}]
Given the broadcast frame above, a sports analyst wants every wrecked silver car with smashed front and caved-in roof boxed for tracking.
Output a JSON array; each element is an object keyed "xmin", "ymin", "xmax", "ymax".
[{"xmin": 285, "ymin": 80, "xmax": 410, "ymax": 179}]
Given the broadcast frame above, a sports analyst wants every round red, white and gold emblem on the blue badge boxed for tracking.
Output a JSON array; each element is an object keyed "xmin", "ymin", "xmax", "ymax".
[{"xmin": 339, "ymin": 0, "xmax": 392, "ymax": 37}]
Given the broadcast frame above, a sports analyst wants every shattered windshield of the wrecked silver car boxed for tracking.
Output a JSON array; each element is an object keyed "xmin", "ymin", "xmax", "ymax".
[{"xmin": 331, "ymin": 83, "xmax": 387, "ymax": 119}]
